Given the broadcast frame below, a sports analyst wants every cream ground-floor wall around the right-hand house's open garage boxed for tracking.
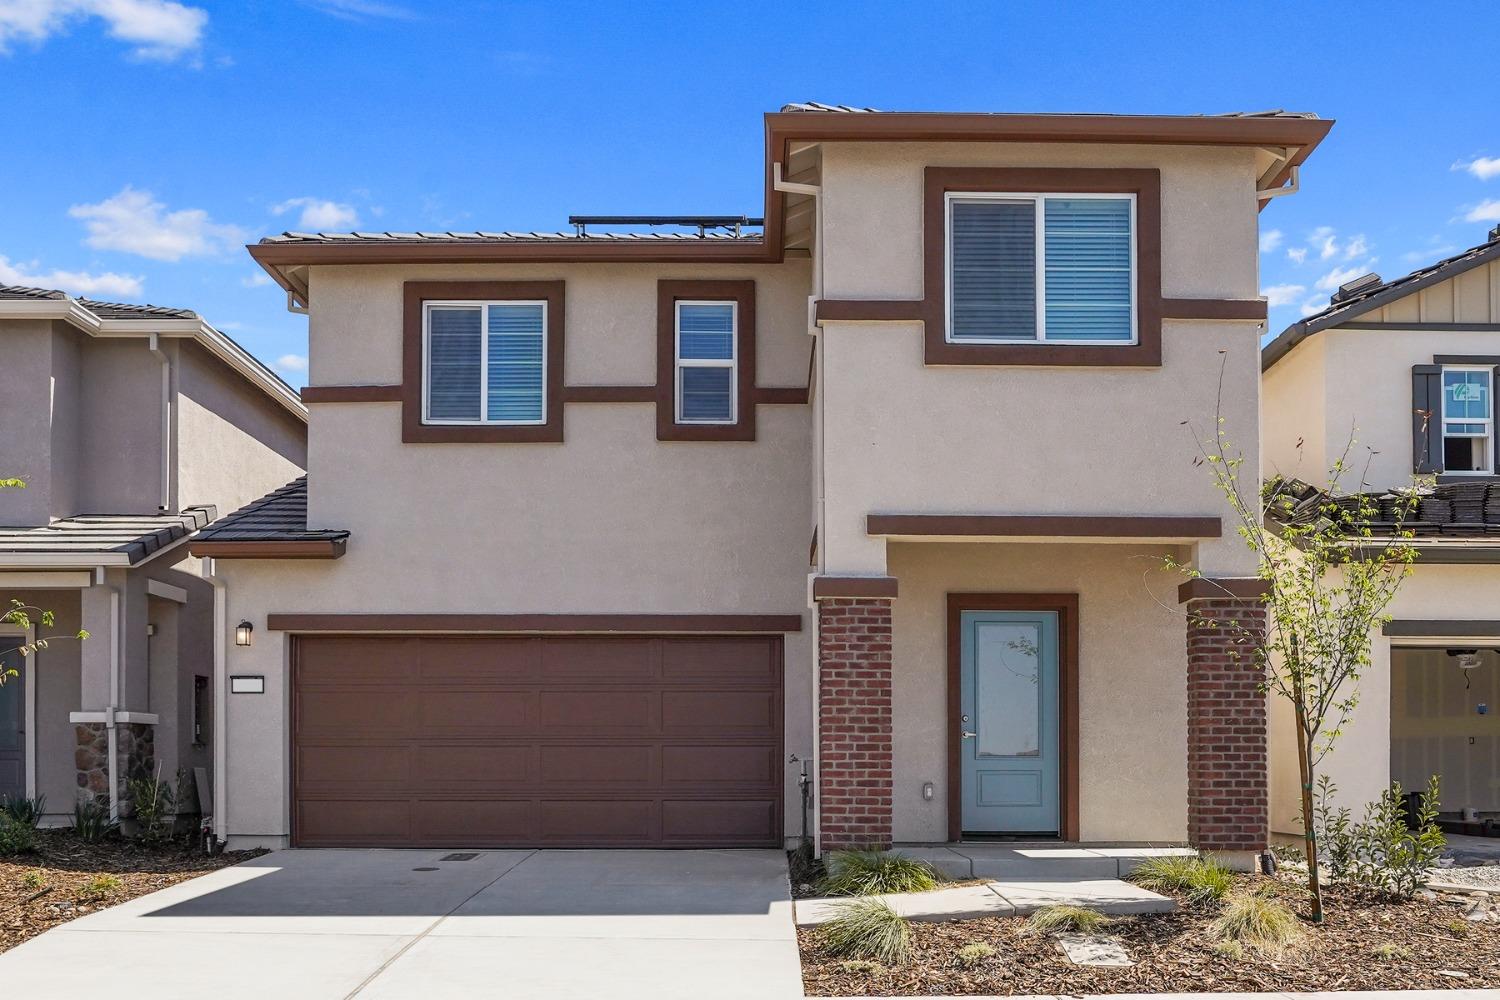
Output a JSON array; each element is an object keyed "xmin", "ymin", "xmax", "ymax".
[{"xmin": 1271, "ymin": 565, "xmax": 1500, "ymax": 832}]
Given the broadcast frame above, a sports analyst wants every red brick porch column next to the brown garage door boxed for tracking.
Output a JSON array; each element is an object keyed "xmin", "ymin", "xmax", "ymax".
[{"xmin": 818, "ymin": 597, "xmax": 891, "ymax": 850}]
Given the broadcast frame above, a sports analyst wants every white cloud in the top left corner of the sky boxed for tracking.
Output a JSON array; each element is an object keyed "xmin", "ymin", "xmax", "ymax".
[{"xmin": 0, "ymin": 0, "xmax": 209, "ymax": 61}]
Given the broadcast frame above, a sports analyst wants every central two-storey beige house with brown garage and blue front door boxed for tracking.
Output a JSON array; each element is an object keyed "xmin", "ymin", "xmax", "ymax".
[{"xmin": 202, "ymin": 105, "xmax": 1331, "ymax": 852}]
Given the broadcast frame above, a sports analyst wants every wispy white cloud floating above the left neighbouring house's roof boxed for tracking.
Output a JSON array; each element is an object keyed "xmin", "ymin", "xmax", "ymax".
[{"xmin": 68, "ymin": 186, "xmax": 249, "ymax": 261}]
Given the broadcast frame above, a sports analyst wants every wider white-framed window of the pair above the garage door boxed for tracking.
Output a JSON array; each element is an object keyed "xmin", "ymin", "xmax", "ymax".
[{"xmin": 422, "ymin": 301, "xmax": 548, "ymax": 424}]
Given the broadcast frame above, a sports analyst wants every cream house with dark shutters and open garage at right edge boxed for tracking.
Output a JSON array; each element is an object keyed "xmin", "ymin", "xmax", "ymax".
[{"xmin": 1262, "ymin": 226, "xmax": 1500, "ymax": 832}]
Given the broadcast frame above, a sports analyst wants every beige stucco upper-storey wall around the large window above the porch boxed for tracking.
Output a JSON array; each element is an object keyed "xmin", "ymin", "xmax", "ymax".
[{"xmin": 821, "ymin": 144, "xmax": 1259, "ymax": 576}]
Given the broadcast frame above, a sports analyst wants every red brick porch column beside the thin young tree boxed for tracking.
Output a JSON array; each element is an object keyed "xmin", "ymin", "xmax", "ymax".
[{"xmin": 1187, "ymin": 597, "xmax": 1271, "ymax": 852}]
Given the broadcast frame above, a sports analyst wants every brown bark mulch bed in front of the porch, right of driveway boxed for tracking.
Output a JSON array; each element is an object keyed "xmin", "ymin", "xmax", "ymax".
[{"xmin": 797, "ymin": 877, "xmax": 1500, "ymax": 997}]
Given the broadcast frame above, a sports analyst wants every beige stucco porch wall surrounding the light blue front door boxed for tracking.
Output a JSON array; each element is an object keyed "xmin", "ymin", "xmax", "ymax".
[{"xmin": 890, "ymin": 543, "xmax": 1188, "ymax": 843}]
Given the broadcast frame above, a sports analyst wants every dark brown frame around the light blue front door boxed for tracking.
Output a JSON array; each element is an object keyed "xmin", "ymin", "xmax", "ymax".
[{"xmin": 948, "ymin": 594, "xmax": 1079, "ymax": 843}]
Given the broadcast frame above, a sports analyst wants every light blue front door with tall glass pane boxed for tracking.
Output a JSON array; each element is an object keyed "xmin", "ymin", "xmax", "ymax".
[{"xmin": 959, "ymin": 612, "xmax": 1062, "ymax": 834}]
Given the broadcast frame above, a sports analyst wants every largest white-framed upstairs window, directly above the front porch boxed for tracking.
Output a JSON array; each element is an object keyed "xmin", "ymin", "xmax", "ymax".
[{"xmin": 948, "ymin": 193, "xmax": 1136, "ymax": 343}]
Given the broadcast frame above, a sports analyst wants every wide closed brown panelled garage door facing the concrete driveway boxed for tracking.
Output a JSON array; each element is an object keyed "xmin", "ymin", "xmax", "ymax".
[{"xmin": 293, "ymin": 636, "xmax": 782, "ymax": 847}]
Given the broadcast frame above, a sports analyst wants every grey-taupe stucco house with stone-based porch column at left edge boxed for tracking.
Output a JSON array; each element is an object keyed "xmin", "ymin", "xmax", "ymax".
[{"xmin": 0, "ymin": 286, "xmax": 306, "ymax": 823}]
